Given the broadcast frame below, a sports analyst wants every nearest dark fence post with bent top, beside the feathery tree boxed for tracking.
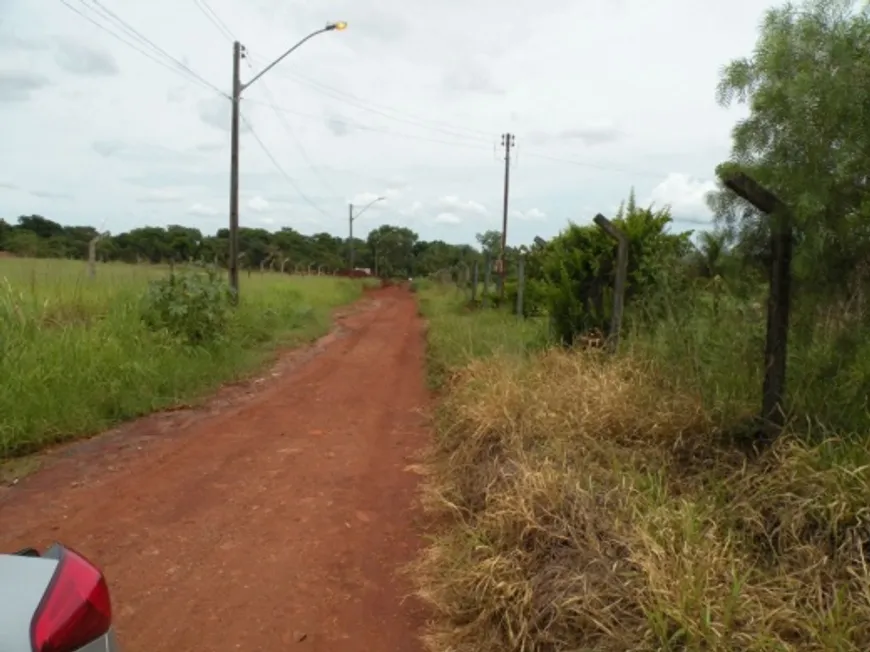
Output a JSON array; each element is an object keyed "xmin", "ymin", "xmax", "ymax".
[{"xmin": 721, "ymin": 172, "xmax": 794, "ymax": 429}]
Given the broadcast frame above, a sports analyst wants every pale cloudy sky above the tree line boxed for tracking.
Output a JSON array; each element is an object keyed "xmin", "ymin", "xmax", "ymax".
[{"xmin": 0, "ymin": 0, "xmax": 770, "ymax": 245}]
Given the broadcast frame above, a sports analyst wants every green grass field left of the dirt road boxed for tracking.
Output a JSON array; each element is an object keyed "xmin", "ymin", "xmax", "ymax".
[{"xmin": 0, "ymin": 259, "xmax": 362, "ymax": 459}]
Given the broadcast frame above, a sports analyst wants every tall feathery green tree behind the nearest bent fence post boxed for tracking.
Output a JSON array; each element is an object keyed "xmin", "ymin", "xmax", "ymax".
[{"xmin": 709, "ymin": 0, "xmax": 870, "ymax": 298}]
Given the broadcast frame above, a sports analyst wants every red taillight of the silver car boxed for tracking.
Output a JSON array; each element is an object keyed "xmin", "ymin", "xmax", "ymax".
[{"xmin": 30, "ymin": 548, "xmax": 112, "ymax": 652}]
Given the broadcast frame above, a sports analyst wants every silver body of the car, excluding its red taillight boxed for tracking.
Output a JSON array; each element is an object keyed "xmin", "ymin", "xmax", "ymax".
[{"xmin": 0, "ymin": 555, "xmax": 119, "ymax": 652}]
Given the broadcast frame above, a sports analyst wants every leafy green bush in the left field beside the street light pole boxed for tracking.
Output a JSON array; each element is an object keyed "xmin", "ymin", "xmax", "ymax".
[{"xmin": 142, "ymin": 270, "xmax": 232, "ymax": 346}]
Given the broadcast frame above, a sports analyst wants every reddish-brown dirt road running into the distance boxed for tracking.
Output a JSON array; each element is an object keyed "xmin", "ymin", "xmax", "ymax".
[{"xmin": 0, "ymin": 288, "xmax": 427, "ymax": 652}]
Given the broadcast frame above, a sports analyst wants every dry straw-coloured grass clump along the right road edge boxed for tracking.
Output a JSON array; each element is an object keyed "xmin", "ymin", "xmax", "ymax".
[{"xmin": 414, "ymin": 352, "xmax": 870, "ymax": 652}]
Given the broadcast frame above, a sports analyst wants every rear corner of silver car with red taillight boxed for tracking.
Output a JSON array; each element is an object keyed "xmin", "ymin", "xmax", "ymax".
[{"xmin": 0, "ymin": 543, "xmax": 119, "ymax": 652}]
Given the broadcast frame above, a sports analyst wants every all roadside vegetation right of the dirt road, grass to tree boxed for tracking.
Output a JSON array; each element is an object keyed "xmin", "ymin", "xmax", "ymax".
[{"xmin": 413, "ymin": 1, "xmax": 870, "ymax": 652}]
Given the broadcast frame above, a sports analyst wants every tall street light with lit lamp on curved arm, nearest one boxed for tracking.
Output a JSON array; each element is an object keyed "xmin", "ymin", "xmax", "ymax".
[{"xmin": 229, "ymin": 21, "xmax": 347, "ymax": 299}]
